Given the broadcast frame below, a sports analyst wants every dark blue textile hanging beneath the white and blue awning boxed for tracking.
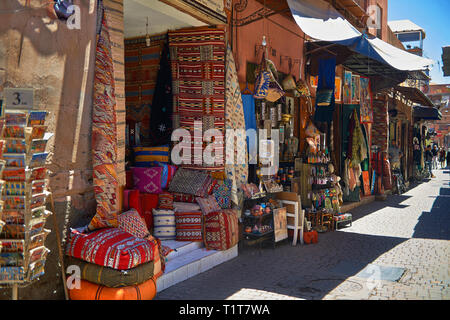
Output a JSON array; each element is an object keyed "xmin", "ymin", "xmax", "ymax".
[{"xmin": 314, "ymin": 58, "xmax": 336, "ymax": 122}]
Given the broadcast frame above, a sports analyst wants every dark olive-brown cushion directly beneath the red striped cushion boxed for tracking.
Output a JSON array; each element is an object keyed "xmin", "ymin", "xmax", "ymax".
[{"xmin": 67, "ymin": 257, "xmax": 154, "ymax": 288}]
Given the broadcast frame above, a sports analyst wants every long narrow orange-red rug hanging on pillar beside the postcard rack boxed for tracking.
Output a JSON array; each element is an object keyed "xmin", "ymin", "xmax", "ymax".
[{"xmin": 88, "ymin": 2, "xmax": 119, "ymax": 230}]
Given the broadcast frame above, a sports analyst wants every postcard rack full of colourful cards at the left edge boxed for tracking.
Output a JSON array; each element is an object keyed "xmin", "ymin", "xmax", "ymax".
[{"xmin": 0, "ymin": 109, "xmax": 52, "ymax": 297}]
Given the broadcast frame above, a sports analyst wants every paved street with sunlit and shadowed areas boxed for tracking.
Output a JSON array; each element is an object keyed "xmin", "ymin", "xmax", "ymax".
[{"xmin": 155, "ymin": 169, "xmax": 450, "ymax": 300}]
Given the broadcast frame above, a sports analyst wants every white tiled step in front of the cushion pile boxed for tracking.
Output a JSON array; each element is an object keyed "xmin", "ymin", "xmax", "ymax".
[{"xmin": 156, "ymin": 245, "xmax": 238, "ymax": 292}]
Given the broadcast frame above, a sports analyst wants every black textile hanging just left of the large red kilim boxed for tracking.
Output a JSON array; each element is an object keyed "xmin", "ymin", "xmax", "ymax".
[{"xmin": 150, "ymin": 38, "xmax": 172, "ymax": 146}]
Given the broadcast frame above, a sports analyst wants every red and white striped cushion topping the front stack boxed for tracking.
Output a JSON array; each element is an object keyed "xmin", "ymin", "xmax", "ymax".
[{"xmin": 66, "ymin": 228, "xmax": 155, "ymax": 270}]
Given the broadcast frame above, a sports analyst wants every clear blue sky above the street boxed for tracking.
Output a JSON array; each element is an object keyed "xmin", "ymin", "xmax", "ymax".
[{"xmin": 388, "ymin": 0, "xmax": 450, "ymax": 84}]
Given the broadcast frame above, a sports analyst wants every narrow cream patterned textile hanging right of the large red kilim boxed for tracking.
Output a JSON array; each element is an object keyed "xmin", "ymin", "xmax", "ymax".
[{"xmin": 225, "ymin": 47, "xmax": 248, "ymax": 204}]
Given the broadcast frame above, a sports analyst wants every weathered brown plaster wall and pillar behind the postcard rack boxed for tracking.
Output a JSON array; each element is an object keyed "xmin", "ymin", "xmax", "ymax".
[{"xmin": 0, "ymin": 0, "xmax": 125, "ymax": 299}]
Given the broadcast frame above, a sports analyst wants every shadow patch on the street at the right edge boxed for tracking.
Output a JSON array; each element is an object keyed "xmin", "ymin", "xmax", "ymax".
[{"xmin": 413, "ymin": 188, "xmax": 450, "ymax": 240}]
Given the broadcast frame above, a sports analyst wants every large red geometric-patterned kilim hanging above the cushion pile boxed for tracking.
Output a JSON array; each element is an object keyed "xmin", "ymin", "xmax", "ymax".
[{"xmin": 169, "ymin": 28, "xmax": 226, "ymax": 172}]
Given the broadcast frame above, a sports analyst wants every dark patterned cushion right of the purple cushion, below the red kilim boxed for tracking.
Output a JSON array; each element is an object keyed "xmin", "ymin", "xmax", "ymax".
[{"xmin": 169, "ymin": 168, "xmax": 214, "ymax": 197}]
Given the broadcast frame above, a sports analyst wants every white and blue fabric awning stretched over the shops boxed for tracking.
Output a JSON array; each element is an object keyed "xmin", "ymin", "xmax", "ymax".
[{"xmin": 287, "ymin": 0, "xmax": 433, "ymax": 71}]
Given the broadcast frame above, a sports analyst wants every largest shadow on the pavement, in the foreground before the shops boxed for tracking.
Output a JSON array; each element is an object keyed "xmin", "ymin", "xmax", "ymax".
[{"xmin": 155, "ymin": 232, "xmax": 407, "ymax": 300}]
